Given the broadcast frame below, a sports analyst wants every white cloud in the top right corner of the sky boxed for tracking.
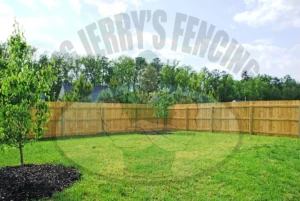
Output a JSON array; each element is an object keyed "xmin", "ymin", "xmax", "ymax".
[{"xmin": 234, "ymin": 0, "xmax": 300, "ymax": 29}]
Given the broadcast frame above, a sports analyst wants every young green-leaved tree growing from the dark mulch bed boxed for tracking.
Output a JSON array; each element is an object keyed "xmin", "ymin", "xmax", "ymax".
[{"xmin": 0, "ymin": 22, "xmax": 53, "ymax": 165}]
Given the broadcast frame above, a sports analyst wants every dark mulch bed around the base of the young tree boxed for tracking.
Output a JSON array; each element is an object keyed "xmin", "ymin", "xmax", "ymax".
[{"xmin": 0, "ymin": 164, "xmax": 80, "ymax": 200}]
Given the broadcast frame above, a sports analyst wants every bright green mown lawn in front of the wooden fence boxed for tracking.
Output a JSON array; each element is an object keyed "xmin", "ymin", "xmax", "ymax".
[{"xmin": 0, "ymin": 132, "xmax": 300, "ymax": 200}]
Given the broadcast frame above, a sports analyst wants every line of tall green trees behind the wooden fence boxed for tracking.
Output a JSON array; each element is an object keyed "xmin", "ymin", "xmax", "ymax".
[{"xmin": 0, "ymin": 44, "xmax": 300, "ymax": 103}]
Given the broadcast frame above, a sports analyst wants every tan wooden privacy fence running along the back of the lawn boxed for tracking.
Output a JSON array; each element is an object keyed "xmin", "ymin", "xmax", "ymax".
[{"xmin": 44, "ymin": 101, "xmax": 300, "ymax": 137}]
